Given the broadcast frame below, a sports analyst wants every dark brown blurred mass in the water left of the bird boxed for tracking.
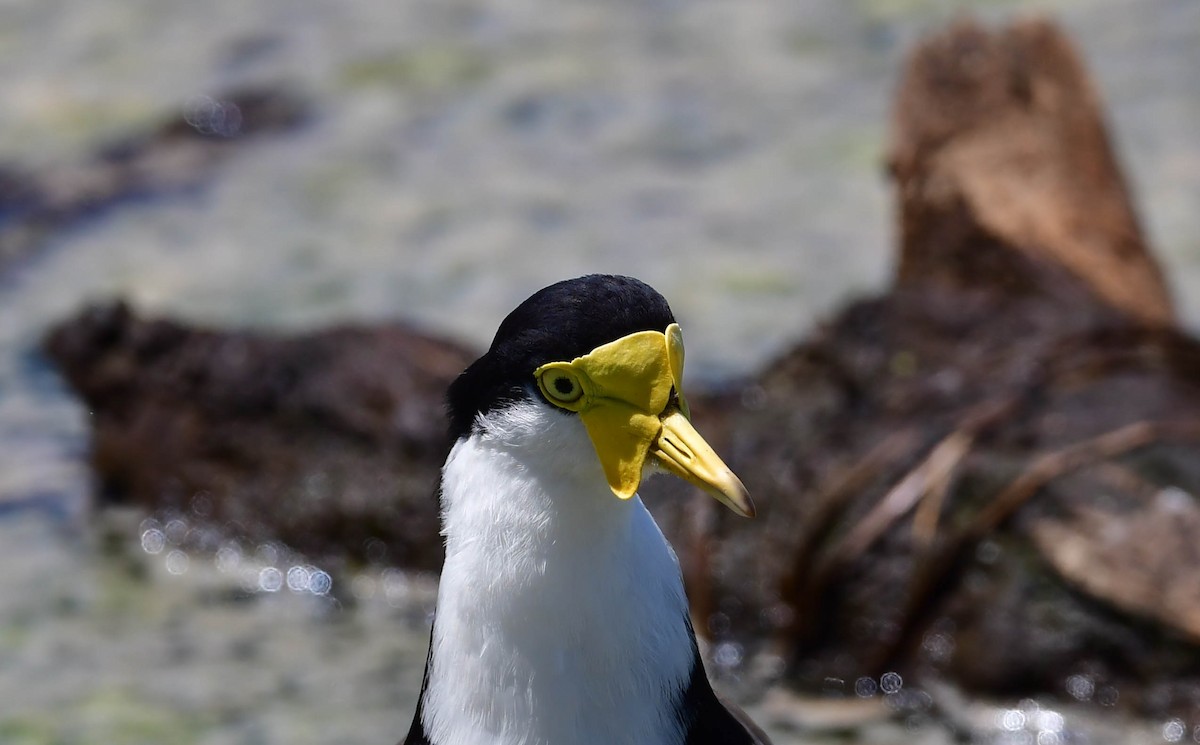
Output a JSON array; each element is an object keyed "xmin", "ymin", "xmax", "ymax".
[{"xmin": 46, "ymin": 298, "xmax": 473, "ymax": 570}]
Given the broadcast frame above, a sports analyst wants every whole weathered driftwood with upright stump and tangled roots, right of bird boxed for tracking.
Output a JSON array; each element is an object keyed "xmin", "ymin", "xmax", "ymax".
[{"xmin": 667, "ymin": 22, "xmax": 1200, "ymax": 711}]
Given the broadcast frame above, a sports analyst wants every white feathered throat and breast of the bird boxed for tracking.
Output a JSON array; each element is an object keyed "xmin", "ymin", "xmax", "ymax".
[{"xmin": 422, "ymin": 403, "xmax": 694, "ymax": 745}]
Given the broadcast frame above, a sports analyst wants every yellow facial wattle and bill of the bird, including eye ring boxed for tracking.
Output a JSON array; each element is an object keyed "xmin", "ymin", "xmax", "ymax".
[{"xmin": 534, "ymin": 324, "xmax": 754, "ymax": 516}]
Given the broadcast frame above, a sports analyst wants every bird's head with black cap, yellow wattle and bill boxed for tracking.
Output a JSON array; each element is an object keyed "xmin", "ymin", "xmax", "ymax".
[{"xmin": 449, "ymin": 275, "xmax": 755, "ymax": 517}]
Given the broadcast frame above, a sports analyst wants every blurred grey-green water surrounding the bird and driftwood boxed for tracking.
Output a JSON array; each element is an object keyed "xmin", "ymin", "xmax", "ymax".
[{"xmin": 0, "ymin": 0, "xmax": 1200, "ymax": 745}]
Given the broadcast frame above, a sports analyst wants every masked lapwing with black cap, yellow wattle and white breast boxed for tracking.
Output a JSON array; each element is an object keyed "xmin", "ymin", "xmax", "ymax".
[{"xmin": 404, "ymin": 275, "xmax": 767, "ymax": 745}]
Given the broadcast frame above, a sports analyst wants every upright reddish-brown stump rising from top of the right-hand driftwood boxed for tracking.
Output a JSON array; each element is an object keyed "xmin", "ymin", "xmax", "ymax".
[{"xmin": 889, "ymin": 20, "xmax": 1172, "ymax": 324}]
